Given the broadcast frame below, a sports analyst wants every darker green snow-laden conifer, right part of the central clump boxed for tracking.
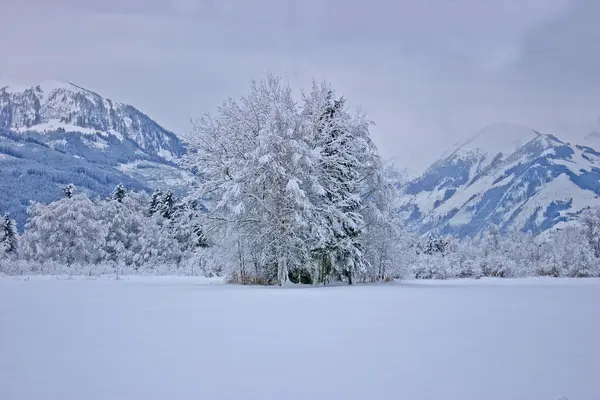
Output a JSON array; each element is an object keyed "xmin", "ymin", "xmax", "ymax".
[{"xmin": 302, "ymin": 83, "xmax": 383, "ymax": 284}]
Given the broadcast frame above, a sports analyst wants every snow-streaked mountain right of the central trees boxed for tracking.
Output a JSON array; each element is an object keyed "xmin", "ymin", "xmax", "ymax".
[{"xmin": 401, "ymin": 124, "xmax": 600, "ymax": 236}]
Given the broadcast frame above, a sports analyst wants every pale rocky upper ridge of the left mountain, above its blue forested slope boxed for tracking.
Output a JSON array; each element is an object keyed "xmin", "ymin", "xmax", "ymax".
[{"xmin": 0, "ymin": 81, "xmax": 184, "ymax": 160}]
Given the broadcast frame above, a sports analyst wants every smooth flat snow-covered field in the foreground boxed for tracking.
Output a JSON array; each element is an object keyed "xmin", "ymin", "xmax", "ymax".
[{"xmin": 0, "ymin": 277, "xmax": 600, "ymax": 400}]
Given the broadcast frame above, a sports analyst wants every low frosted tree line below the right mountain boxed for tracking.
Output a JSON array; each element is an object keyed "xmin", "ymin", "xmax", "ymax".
[{"xmin": 410, "ymin": 219, "xmax": 600, "ymax": 279}]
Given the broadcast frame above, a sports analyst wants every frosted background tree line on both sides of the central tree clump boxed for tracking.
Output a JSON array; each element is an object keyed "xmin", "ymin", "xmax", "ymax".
[{"xmin": 0, "ymin": 182, "xmax": 600, "ymax": 283}]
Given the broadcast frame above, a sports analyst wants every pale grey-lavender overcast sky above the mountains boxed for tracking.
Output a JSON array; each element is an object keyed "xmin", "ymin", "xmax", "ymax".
[{"xmin": 0, "ymin": 0, "xmax": 600, "ymax": 171}]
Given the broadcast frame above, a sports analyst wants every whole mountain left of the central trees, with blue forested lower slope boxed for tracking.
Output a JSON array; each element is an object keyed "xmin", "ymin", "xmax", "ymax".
[{"xmin": 0, "ymin": 81, "xmax": 190, "ymax": 227}]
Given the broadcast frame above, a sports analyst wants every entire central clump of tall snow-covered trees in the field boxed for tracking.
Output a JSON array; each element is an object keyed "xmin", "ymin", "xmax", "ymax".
[{"xmin": 184, "ymin": 75, "xmax": 394, "ymax": 285}]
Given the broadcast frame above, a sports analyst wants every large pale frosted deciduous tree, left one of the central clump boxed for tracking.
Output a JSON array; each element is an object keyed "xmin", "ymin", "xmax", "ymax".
[{"xmin": 185, "ymin": 76, "xmax": 314, "ymax": 285}]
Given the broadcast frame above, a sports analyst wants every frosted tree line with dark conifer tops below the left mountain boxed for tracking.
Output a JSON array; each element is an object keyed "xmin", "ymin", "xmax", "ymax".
[{"xmin": 0, "ymin": 185, "xmax": 218, "ymax": 274}]
